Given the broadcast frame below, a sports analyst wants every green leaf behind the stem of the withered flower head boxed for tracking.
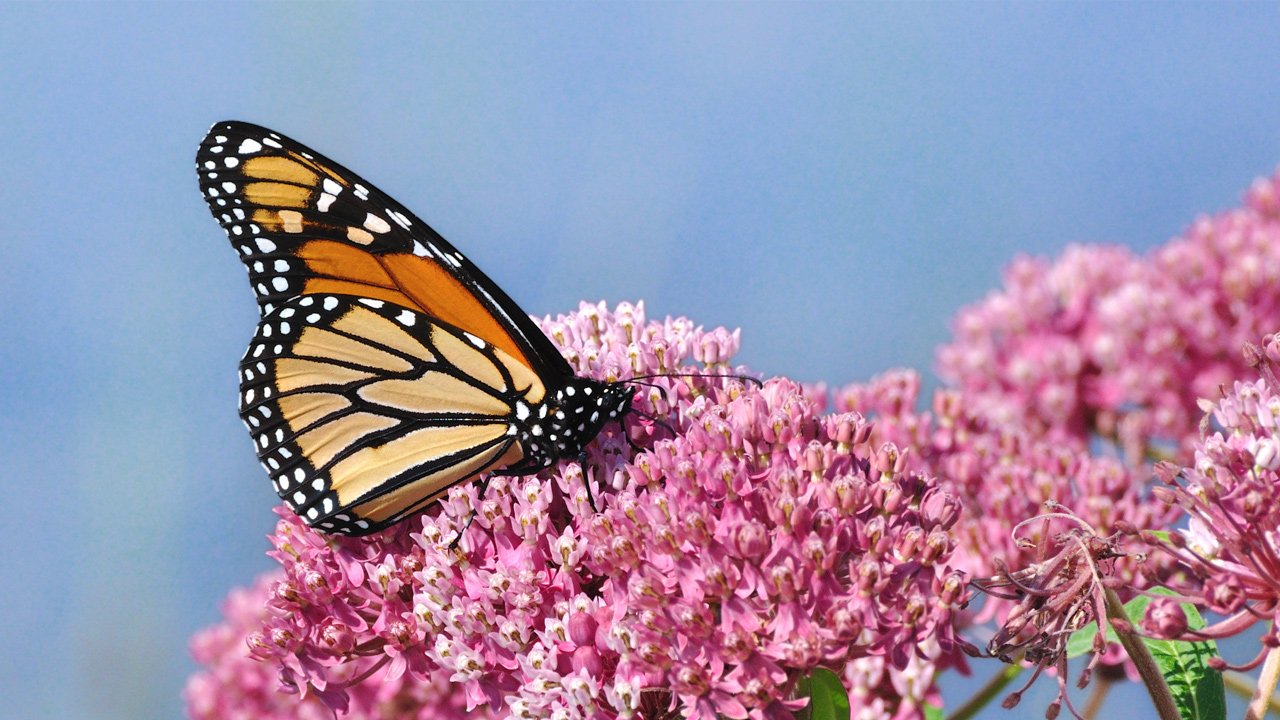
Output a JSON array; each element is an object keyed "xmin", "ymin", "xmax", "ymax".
[{"xmin": 1066, "ymin": 588, "xmax": 1226, "ymax": 720}]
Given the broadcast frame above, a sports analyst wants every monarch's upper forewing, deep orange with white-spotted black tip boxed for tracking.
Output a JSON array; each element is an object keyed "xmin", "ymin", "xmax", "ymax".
[{"xmin": 196, "ymin": 122, "xmax": 573, "ymax": 382}]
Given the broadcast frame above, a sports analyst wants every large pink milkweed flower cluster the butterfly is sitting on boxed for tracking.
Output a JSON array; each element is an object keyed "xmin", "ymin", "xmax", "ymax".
[{"xmin": 188, "ymin": 304, "xmax": 966, "ymax": 720}]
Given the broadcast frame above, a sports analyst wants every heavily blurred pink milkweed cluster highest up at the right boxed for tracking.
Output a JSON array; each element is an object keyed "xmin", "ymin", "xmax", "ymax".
[{"xmin": 938, "ymin": 166, "xmax": 1280, "ymax": 465}]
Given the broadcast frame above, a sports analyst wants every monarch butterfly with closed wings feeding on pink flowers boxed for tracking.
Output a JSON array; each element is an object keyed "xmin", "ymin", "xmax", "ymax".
[{"xmin": 196, "ymin": 122, "xmax": 634, "ymax": 536}]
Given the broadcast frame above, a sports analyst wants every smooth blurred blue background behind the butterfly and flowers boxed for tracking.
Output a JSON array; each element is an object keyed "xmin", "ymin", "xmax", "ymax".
[{"xmin": 0, "ymin": 3, "xmax": 1280, "ymax": 720}]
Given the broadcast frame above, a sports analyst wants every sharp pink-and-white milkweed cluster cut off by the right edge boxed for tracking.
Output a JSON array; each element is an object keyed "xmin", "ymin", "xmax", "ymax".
[{"xmin": 1142, "ymin": 337, "xmax": 1280, "ymax": 669}]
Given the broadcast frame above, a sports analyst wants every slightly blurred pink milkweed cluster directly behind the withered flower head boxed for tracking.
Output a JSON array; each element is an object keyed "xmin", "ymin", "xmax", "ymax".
[{"xmin": 835, "ymin": 370, "xmax": 1180, "ymax": 622}]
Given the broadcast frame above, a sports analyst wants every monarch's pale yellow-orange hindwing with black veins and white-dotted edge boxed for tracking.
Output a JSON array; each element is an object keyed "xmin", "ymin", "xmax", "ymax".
[{"xmin": 241, "ymin": 295, "xmax": 544, "ymax": 534}]
